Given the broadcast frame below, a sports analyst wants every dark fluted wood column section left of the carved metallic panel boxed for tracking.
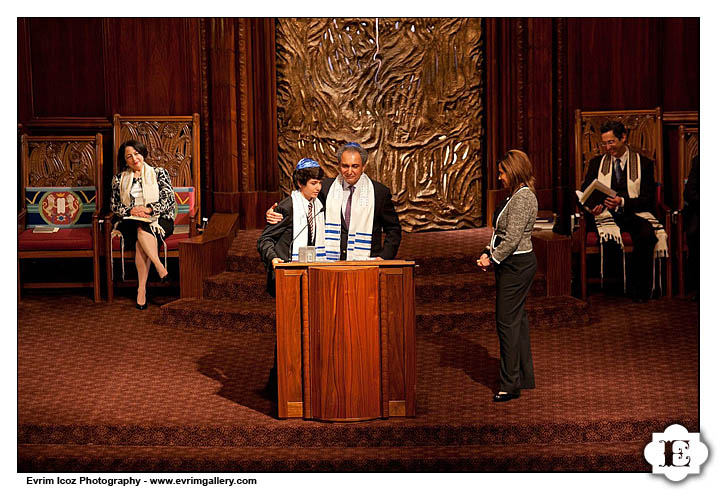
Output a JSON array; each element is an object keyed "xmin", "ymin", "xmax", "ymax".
[{"xmin": 205, "ymin": 18, "xmax": 279, "ymax": 229}]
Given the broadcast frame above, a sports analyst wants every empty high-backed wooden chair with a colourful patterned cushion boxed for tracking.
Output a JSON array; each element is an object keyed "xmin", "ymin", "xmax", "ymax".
[{"xmin": 18, "ymin": 133, "xmax": 102, "ymax": 302}]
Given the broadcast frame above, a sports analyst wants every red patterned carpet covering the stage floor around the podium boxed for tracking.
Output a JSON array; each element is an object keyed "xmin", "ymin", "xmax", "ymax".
[{"xmin": 18, "ymin": 232, "xmax": 699, "ymax": 472}]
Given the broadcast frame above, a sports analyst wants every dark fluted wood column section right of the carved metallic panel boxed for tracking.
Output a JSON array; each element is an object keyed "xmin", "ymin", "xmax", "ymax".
[{"xmin": 486, "ymin": 18, "xmax": 569, "ymax": 224}]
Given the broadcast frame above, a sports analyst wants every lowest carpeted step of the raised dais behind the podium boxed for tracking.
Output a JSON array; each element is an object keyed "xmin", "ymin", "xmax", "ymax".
[{"xmin": 160, "ymin": 295, "xmax": 589, "ymax": 332}]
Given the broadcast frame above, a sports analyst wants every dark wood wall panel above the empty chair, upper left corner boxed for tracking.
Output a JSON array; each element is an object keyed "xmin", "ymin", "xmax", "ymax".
[{"xmin": 26, "ymin": 18, "xmax": 107, "ymax": 117}]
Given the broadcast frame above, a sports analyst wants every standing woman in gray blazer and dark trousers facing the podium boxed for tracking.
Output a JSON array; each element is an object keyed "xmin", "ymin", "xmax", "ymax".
[{"xmin": 476, "ymin": 150, "xmax": 538, "ymax": 402}]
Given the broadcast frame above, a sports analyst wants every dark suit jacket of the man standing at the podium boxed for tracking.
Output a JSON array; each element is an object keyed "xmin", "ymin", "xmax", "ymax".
[{"xmin": 319, "ymin": 177, "xmax": 401, "ymax": 259}]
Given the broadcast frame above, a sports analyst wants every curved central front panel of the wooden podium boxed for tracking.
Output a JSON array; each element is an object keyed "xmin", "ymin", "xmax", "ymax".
[{"xmin": 309, "ymin": 266, "xmax": 382, "ymax": 421}]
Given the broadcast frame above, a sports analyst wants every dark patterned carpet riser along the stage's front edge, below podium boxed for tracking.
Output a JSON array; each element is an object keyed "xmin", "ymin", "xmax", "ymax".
[{"xmin": 17, "ymin": 418, "xmax": 698, "ymax": 456}]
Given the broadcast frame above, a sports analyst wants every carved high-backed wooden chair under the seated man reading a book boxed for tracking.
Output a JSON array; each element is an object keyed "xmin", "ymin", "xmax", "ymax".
[{"xmin": 573, "ymin": 107, "xmax": 671, "ymax": 298}]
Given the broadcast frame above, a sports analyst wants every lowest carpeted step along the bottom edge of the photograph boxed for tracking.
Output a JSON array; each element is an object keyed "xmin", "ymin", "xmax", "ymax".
[{"xmin": 18, "ymin": 440, "xmax": 651, "ymax": 474}]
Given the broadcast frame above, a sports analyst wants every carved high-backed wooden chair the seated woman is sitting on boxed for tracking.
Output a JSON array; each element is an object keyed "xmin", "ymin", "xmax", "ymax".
[{"xmin": 105, "ymin": 113, "xmax": 201, "ymax": 301}]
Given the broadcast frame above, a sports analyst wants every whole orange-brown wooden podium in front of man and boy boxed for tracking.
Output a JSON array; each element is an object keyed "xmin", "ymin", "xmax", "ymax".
[{"xmin": 275, "ymin": 261, "xmax": 416, "ymax": 421}]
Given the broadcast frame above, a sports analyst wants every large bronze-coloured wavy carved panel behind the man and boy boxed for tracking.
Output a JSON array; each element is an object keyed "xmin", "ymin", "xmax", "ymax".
[{"xmin": 276, "ymin": 18, "xmax": 484, "ymax": 231}]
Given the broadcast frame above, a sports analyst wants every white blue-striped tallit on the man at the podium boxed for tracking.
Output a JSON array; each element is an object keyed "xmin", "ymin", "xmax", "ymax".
[{"xmin": 325, "ymin": 174, "xmax": 374, "ymax": 261}]
